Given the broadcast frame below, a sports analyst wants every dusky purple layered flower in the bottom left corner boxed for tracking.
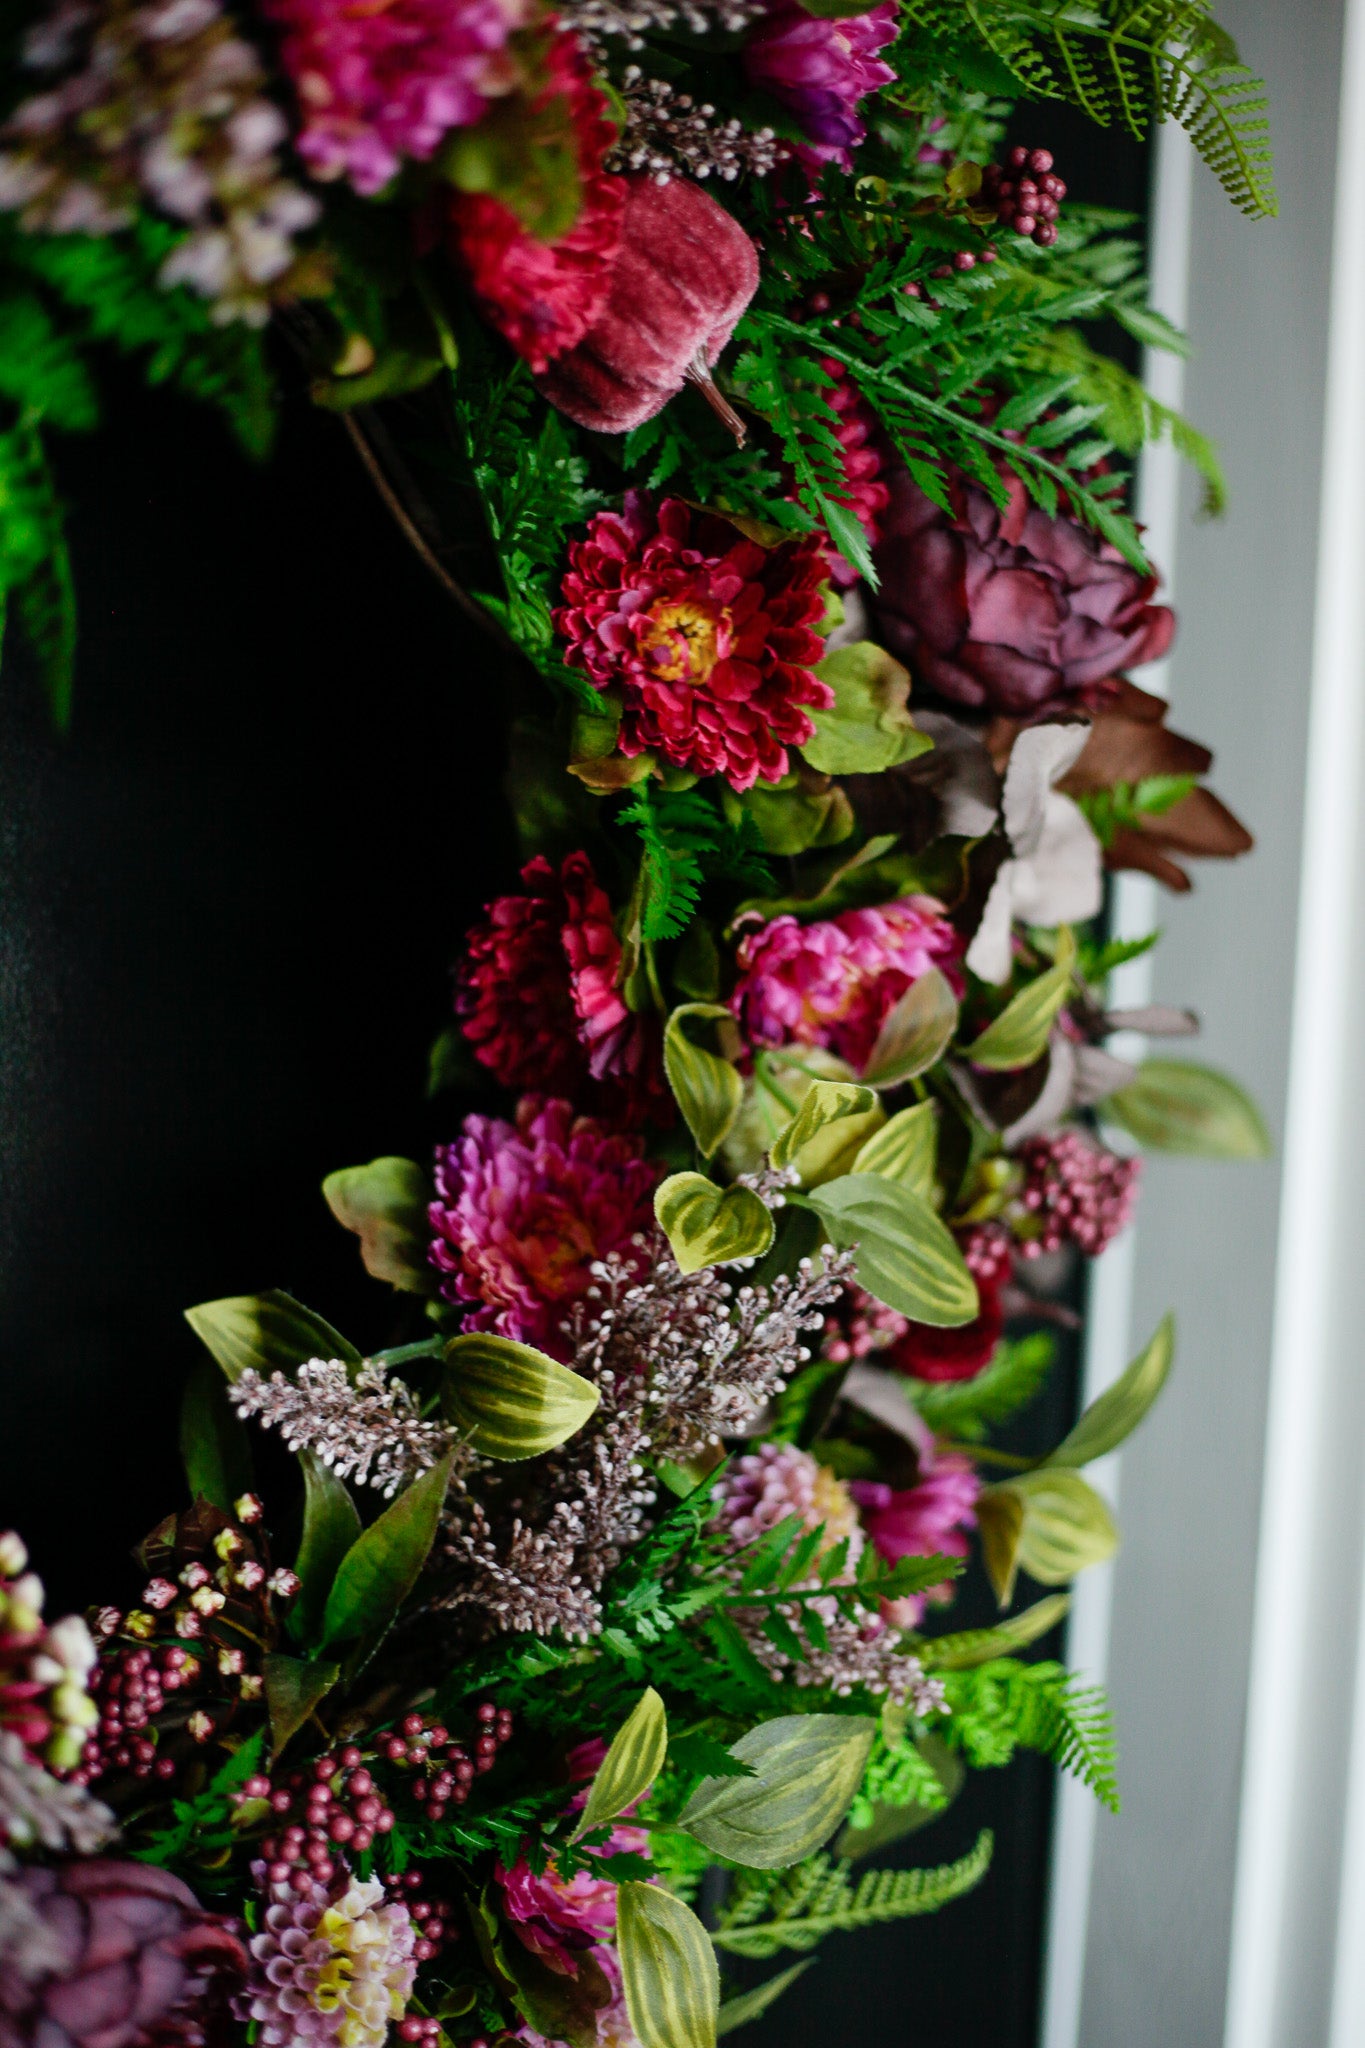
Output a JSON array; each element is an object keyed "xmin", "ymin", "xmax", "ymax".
[{"xmin": 0, "ymin": 1858, "xmax": 246, "ymax": 2048}]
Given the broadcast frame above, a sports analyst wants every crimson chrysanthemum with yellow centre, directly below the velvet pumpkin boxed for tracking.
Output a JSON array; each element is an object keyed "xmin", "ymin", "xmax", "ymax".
[{"xmin": 555, "ymin": 492, "xmax": 833, "ymax": 788}]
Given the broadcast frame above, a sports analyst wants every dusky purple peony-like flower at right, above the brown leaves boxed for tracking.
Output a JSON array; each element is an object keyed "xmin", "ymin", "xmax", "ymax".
[{"xmin": 874, "ymin": 467, "xmax": 1175, "ymax": 717}]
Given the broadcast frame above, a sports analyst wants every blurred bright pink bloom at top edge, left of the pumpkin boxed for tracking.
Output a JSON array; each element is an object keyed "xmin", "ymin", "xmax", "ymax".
[{"xmin": 264, "ymin": 0, "xmax": 526, "ymax": 195}]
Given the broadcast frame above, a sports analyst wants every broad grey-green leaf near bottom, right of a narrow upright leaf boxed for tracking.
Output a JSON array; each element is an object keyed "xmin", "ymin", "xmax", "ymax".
[{"xmin": 677, "ymin": 1714, "xmax": 876, "ymax": 1870}]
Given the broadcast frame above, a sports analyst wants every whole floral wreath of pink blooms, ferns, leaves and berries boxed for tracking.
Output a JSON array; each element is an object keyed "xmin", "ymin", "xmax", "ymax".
[{"xmin": 0, "ymin": 0, "xmax": 1275, "ymax": 2048}]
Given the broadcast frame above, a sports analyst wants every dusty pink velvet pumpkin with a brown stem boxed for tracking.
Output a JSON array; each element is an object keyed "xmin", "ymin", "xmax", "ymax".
[{"xmin": 536, "ymin": 176, "xmax": 759, "ymax": 440}]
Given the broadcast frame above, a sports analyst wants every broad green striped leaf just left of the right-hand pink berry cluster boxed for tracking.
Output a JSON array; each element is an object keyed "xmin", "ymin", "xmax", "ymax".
[{"xmin": 804, "ymin": 1174, "xmax": 978, "ymax": 1329}]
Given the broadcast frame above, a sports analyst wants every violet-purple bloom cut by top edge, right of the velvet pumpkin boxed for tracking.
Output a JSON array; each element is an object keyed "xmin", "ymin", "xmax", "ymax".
[{"xmin": 743, "ymin": 0, "xmax": 896, "ymax": 170}]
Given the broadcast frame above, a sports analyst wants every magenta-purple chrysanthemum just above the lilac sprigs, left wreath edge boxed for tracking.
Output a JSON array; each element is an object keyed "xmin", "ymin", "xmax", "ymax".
[{"xmin": 430, "ymin": 1096, "xmax": 659, "ymax": 1358}]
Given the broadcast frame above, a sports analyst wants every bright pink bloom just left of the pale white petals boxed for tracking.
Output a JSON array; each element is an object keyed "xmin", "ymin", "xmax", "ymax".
[{"xmin": 731, "ymin": 895, "xmax": 962, "ymax": 1071}]
